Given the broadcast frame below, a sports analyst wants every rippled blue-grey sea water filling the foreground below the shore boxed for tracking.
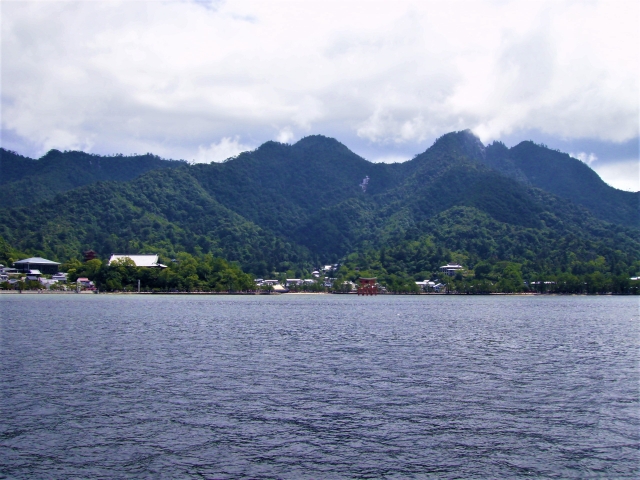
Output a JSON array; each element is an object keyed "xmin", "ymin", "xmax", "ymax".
[{"xmin": 0, "ymin": 294, "xmax": 640, "ymax": 478}]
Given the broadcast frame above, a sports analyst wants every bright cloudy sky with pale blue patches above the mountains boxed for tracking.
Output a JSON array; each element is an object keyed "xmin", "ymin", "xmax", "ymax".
[{"xmin": 0, "ymin": 0, "xmax": 640, "ymax": 191}]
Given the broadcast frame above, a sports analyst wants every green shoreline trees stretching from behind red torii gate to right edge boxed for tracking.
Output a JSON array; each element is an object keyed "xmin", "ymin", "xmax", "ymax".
[{"xmin": 335, "ymin": 237, "xmax": 640, "ymax": 294}]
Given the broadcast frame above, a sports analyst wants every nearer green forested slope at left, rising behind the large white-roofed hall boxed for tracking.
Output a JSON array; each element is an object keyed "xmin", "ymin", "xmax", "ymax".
[{"xmin": 0, "ymin": 166, "xmax": 309, "ymax": 273}]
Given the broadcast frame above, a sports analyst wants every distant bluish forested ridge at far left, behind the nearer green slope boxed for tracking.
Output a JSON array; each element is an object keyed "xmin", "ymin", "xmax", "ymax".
[{"xmin": 0, "ymin": 148, "xmax": 185, "ymax": 207}]
